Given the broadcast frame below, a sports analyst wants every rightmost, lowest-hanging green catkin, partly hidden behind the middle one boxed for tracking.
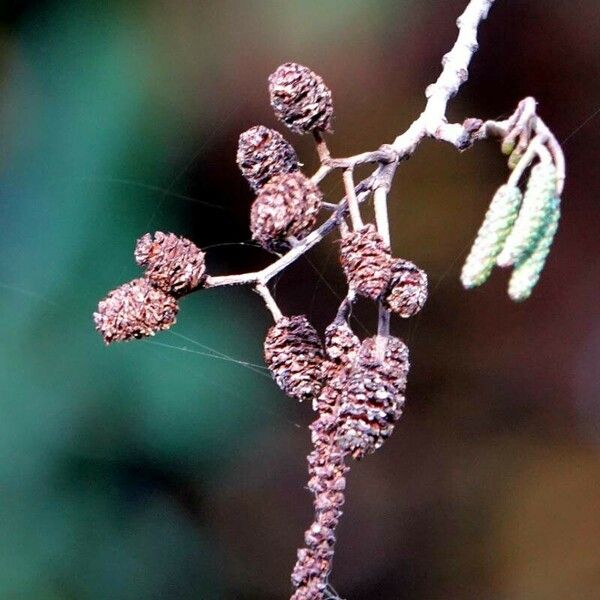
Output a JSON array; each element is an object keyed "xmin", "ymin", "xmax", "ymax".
[{"xmin": 508, "ymin": 197, "xmax": 560, "ymax": 302}]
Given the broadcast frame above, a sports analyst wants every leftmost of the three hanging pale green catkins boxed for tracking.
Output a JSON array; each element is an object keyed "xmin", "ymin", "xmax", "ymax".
[{"xmin": 460, "ymin": 185, "xmax": 522, "ymax": 289}]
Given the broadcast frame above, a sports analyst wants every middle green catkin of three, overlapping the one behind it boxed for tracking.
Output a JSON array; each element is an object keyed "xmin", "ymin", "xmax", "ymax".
[{"xmin": 496, "ymin": 163, "xmax": 556, "ymax": 267}]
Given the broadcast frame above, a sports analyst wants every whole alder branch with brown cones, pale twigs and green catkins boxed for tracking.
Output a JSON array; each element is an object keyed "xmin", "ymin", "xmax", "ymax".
[{"xmin": 94, "ymin": 0, "xmax": 565, "ymax": 600}]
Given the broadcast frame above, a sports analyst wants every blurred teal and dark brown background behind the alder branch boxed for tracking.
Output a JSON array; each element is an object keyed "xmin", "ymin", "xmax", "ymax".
[{"xmin": 0, "ymin": 0, "xmax": 600, "ymax": 600}]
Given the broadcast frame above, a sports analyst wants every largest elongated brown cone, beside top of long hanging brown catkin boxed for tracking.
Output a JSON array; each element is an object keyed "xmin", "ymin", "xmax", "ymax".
[{"xmin": 336, "ymin": 336, "xmax": 409, "ymax": 459}]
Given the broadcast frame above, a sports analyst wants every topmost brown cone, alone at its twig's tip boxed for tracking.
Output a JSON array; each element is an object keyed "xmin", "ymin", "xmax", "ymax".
[{"xmin": 269, "ymin": 63, "xmax": 333, "ymax": 133}]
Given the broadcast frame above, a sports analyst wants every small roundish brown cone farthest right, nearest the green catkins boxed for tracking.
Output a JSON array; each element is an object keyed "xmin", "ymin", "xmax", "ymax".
[{"xmin": 383, "ymin": 258, "xmax": 427, "ymax": 319}]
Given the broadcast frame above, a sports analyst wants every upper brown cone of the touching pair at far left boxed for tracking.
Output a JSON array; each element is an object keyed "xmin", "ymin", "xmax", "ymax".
[{"xmin": 134, "ymin": 231, "xmax": 206, "ymax": 296}]
